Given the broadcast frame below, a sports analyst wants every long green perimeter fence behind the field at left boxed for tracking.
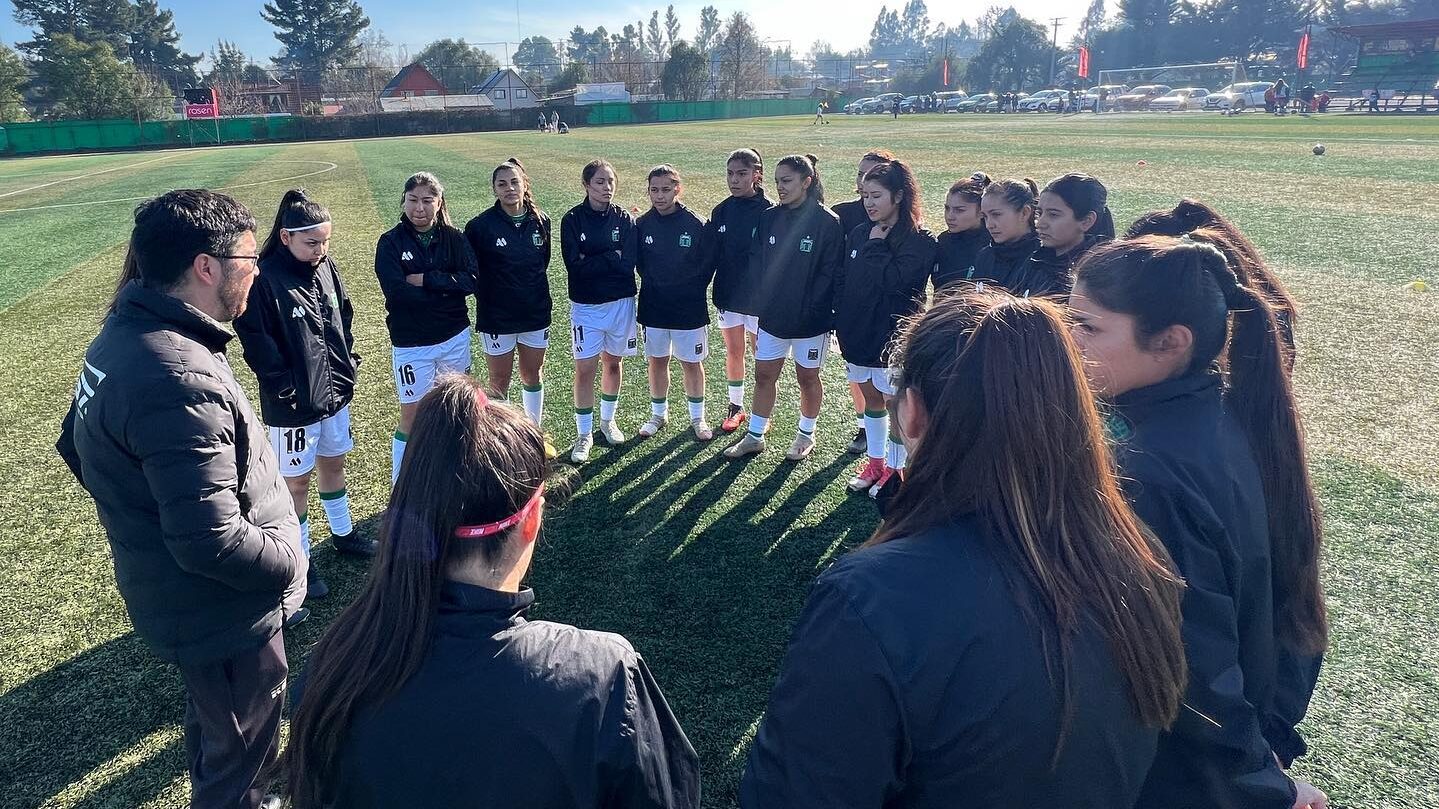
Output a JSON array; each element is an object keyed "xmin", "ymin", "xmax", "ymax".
[{"xmin": 0, "ymin": 98, "xmax": 840, "ymax": 157}]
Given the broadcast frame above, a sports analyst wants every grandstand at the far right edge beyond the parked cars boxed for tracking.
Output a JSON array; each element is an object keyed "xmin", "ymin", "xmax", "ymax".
[{"xmin": 1330, "ymin": 19, "xmax": 1439, "ymax": 111}]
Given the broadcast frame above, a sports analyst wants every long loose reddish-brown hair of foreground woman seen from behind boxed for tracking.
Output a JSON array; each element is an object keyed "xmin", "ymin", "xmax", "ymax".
[{"xmin": 866, "ymin": 291, "xmax": 1186, "ymax": 757}]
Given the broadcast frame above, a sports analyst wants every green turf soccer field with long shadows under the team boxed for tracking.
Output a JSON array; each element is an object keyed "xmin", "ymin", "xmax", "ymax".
[{"xmin": 0, "ymin": 114, "xmax": 1439, "ymax": 808}]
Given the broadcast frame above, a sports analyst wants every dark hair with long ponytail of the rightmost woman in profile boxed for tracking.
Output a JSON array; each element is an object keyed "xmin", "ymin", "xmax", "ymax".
[{"xmin": 1075, "ymin": 236, "xmax": 1328, "ymax": 654}]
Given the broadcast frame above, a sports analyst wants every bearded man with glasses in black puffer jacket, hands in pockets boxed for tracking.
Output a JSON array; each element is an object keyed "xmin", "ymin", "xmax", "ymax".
[{"xmin": 56, "ymin": 190, "xmax": 307, "ymax": 809}]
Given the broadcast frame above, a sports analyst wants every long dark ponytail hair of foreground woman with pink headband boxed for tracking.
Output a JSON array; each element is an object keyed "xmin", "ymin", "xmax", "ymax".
[{"xmin": 281, "ymin": 374, "xmax": 563, "ymax": 809}]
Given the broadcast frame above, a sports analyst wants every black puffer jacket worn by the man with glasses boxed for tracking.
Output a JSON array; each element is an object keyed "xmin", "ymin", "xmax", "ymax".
[{"xmin": 56, "ymin": 282, "xmax": 307, "ymax": 664}]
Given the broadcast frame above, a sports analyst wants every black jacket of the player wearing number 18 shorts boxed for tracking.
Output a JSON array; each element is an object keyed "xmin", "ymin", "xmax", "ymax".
[{"xmin": 235, "ymin": 248, "xmax": 360, "ymax": 428}]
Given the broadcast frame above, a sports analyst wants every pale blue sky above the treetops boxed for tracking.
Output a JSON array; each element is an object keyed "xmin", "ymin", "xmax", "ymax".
[{"xmin": 0, "ymin": 0, "xmax": 1088, "ymax": 62}]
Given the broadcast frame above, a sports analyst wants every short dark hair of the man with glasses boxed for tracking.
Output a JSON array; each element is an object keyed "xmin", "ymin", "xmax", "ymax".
[{"xmin": 109, "ymin": 189, "xmax": 255, "ymax": 311}]
